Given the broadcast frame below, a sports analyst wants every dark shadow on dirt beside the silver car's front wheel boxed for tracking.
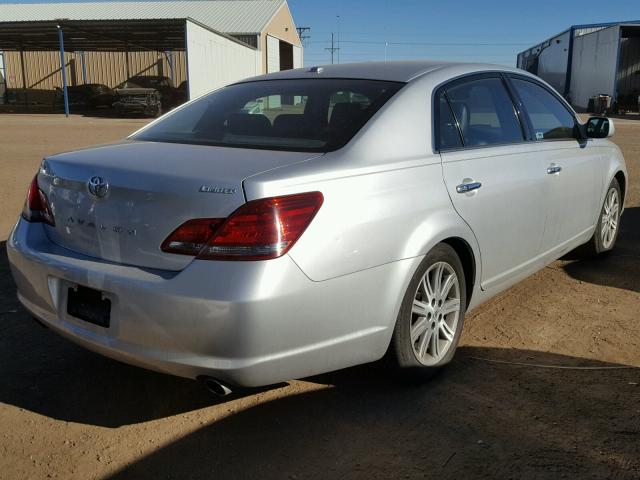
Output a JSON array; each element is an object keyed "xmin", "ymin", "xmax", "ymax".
[{"xmin": 563, "ymin": 207, "xmax": 640, "ymax": 292}]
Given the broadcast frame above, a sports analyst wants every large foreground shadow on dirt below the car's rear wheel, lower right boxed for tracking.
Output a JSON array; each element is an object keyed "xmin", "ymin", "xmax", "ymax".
[{"xmin": 102, "ymin": 347, "xmax": 640, "ymax": 480}]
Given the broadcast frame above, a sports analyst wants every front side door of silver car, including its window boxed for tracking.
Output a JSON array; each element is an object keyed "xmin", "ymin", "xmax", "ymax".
[{"xmin": 509, "ymin": 75, "xmax": 606, "ymax": 253}]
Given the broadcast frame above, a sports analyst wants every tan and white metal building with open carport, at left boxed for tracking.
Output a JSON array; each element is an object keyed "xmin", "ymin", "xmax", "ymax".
[{"xmin": 0, "ymin": 0, "xmax": 303, "ymax": 111}]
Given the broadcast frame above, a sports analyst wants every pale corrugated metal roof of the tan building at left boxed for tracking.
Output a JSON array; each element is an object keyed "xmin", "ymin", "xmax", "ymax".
[{"xmin": 0, "ymin": 0, "xmax": 286, "ymax": 33}]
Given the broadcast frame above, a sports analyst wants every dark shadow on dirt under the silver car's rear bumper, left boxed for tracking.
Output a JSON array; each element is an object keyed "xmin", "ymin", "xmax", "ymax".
[{"xmin": 0, "ymin": 242, "xmax": 280, "ymax": 428}]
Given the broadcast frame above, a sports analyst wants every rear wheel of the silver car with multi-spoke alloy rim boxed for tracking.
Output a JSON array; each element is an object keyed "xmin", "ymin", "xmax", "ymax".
[{"xmin": 389, "ymin": 243, "xmax": 467, "ymax": 379}]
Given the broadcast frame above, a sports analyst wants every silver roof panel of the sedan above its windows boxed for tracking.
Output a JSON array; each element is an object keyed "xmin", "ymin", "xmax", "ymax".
[{"xmin": 238, "ymin": 61, "xmax": 526, "ymax": 83}]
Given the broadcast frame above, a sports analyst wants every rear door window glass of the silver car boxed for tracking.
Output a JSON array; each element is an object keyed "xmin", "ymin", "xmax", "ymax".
[{"xmin": 446, "ymin": 78, "xmax": 524, "ymax": 147}]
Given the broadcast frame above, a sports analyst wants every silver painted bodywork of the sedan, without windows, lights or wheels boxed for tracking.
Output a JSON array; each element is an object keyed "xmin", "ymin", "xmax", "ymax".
[{"xmin": 7, "ymin": 62, "xmax": 626, "ymax": 385}]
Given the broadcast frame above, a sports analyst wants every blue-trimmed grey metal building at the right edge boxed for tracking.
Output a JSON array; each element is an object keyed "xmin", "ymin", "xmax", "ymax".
[{"xmin": 518, "ymin": 21, "xmax": 640, "ymax": 111}]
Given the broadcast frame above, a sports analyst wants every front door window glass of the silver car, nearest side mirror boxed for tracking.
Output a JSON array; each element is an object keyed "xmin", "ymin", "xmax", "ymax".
[{"xmin": 511, "ymin": 78, "xmax": 576, "ymax": 140}]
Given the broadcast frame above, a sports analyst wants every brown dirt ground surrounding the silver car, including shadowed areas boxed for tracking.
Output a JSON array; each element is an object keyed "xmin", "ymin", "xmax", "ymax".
[{"xmin": 0, "ymin": 115, "xmax": 640, "ymax": 480}]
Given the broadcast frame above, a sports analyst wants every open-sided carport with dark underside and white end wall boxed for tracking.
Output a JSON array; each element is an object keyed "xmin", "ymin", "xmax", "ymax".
[{"xmin": 0, "ymin": 18, "xmax": 259, "ymax": 116}]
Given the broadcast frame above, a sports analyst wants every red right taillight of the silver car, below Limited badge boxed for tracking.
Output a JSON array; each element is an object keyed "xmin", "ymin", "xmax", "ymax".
[{"xmin": 162, "ymin": 192, "xmax": 323, "ymax": 260}]
